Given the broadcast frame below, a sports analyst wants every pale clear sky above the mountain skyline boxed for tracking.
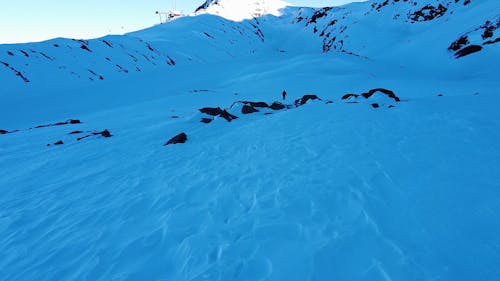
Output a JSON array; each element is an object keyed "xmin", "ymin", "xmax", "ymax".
[{"xmin": 0, "ymin": 0, "xmax": 359, "ymax": 43}]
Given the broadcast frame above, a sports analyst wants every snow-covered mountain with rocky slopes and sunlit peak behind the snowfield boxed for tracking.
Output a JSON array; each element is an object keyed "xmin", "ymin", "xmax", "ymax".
[{"xmin": 0, "ymin": 0, "xmax": 500, "ymax": 89}]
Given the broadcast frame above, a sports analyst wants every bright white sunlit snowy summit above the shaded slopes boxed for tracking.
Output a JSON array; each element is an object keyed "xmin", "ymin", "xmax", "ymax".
[{"xmin": 195, "ymin": 0, "xmax": 290, "ymax": 21}]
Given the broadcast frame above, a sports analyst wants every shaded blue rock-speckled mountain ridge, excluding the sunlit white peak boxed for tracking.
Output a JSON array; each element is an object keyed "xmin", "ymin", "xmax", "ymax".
[{"xmin": 0, "ymin": 0, "xmax": 500, "ymax": 91}]
